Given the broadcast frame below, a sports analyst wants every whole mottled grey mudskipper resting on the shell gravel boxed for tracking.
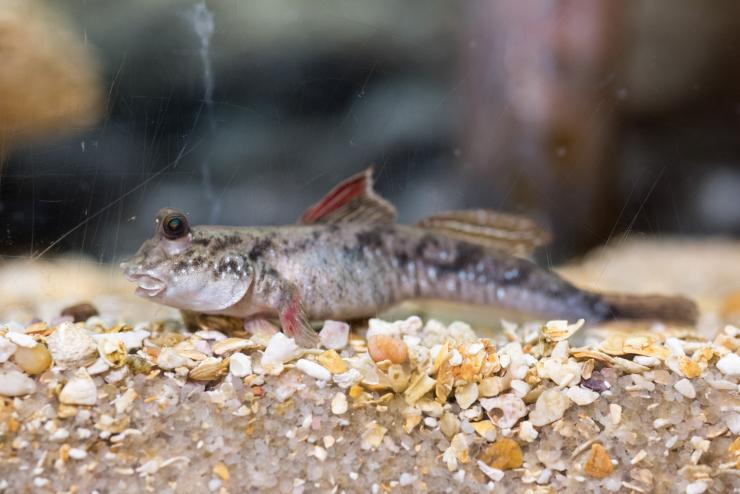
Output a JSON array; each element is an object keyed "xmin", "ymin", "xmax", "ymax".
[{"xmin": 121, "ymin": 168, "xmax": 697, "ymax": 345}]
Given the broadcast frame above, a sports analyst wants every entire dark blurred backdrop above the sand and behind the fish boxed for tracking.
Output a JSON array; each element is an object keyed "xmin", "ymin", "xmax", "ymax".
[{"xmin": 0, "ymin": 0, "xmax": 740, "ymax": 262}]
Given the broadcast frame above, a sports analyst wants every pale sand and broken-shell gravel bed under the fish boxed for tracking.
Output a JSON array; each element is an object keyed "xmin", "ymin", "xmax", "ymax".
[{"xmin": 0, "ymin": 237, "xmax": 740, "ymax": 494}]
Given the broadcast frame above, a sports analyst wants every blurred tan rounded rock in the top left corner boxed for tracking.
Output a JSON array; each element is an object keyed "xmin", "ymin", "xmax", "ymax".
[{"xmin": 0, "ymin": 0, "xmax": 102, "ymax": 159}]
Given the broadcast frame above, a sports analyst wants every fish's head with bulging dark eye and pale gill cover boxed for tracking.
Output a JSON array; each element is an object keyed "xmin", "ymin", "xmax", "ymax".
[{"xmin": 121, "ymin": 208, "xmax": 252, "ymax": 312}]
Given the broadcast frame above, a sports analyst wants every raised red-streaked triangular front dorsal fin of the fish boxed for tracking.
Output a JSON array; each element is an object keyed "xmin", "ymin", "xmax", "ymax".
[{"xmin": 299, "ymin": 167, "xmax": 396, "ymax": 225}]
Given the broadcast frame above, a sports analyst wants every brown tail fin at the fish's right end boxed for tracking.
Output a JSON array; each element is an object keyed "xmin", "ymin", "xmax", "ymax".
[{"xmin": 602, "ymin": 293, "xmax": 699, "ymax": 325}]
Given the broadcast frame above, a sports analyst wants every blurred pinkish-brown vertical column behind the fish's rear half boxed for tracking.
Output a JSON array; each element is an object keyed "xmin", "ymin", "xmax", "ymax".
[{"xmin": 461, "ymin": 0, "xmax": 629, "ymax": 253}]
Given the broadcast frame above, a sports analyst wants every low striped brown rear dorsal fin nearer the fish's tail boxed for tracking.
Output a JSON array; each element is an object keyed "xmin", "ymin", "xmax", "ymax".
[{"xmin": 417, "ymin": 209, "xmax": 550, "ymax": 256}]
